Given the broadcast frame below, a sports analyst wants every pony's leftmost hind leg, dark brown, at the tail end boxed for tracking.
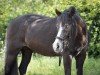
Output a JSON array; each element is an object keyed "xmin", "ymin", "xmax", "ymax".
[{"xmin": 4, "ymin": 48, "xmax": 19, "ymax": 75}]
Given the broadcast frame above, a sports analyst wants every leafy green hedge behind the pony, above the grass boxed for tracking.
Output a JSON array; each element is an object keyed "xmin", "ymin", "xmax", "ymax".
[{"xmin": 0, "ymin": 0, "xmax": 100, "ymax": 57}]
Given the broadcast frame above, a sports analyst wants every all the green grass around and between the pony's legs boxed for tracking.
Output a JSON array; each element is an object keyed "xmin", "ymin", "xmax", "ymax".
[{"xmin": 0, "ymin": 56, "xmax": 100, "ymax": 75}]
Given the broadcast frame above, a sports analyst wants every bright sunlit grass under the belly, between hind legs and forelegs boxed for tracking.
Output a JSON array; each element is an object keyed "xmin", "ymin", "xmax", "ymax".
[{"xmin": 27, "ymin": 57, "xmax": 64, "ymax": 75}]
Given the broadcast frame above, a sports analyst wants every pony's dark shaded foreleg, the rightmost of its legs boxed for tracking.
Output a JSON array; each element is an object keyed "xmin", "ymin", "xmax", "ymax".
[{"xmin": 75, "ymin": 51, "xmax": 86, "ymax": 75}]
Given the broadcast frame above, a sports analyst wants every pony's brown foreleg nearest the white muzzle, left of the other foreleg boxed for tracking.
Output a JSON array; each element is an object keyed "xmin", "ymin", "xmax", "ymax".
[{"xmin": 63, "ymin": 52, "xmax": 72, "ymax": 75}]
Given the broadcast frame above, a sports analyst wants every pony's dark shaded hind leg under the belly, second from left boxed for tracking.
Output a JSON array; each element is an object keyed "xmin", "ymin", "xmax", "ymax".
[{"xmin": 19, "ymin": 47, "xmax": 32, "ymax": 75}]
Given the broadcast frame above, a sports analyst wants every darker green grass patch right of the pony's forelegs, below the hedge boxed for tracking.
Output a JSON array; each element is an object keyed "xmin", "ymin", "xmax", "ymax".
[{"xmin": 84, "ymin": 58, "xmax": 100, "ymax": 75}]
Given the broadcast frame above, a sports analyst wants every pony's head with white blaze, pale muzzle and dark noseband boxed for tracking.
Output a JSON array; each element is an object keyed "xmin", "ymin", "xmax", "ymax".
[{"xmin": 53, "ymin": 7, "xmax": 76, "ymax": 53}]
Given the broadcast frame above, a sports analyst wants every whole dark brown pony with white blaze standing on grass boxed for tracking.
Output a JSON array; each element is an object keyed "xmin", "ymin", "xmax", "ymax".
[{"xmin": 4, "ymin": 7, "xmax": 87, "ymax": 75}]
